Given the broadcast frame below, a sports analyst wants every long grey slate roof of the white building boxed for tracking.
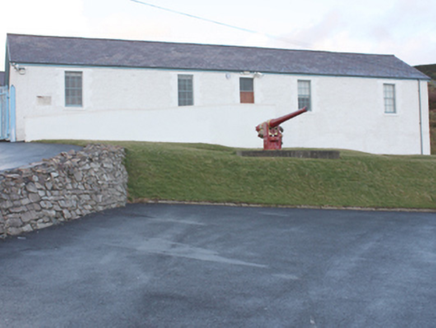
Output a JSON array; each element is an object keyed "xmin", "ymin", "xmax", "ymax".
[{"xmin": 7, "ymin": 34, "xmax": 429, "ymax": 79}]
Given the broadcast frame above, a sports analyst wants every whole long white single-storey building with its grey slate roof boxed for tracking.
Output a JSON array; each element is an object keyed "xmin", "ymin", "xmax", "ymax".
[{"xmin": 5, "ymin": 34, "xmax": 430, "ymax": 154}]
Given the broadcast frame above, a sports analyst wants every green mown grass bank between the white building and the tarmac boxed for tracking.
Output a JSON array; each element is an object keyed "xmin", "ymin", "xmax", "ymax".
[{"xmin": 47, "ymin": 142, "xmax": 436, "ymax": 208}]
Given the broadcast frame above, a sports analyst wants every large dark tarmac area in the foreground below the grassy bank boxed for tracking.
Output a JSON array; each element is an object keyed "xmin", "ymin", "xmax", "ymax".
[{"xmin": 0, "ymin": 204, "xmax": 436, "ymax": 328}]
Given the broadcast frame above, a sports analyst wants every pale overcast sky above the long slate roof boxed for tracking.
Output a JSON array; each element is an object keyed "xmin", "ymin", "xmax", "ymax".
[{"xmin": 0, "ymin": 0, "xmax": 436, "ymax": 70}]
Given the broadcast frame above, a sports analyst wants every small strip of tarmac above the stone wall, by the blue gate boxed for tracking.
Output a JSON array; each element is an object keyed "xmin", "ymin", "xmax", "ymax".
[{"xmin": 0, "ymin": 142, "xmax": 83, "ymax": 171}]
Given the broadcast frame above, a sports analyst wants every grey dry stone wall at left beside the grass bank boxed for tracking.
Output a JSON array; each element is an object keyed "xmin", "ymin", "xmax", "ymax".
[{"xmin": 0, "ymin": 145, "xmax": 127, "ymax": 237}]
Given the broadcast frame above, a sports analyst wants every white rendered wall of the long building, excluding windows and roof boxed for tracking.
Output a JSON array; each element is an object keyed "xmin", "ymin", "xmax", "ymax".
[{"xmin": 11, "ymin": 65, "xmax": 430, "ymax": 154}]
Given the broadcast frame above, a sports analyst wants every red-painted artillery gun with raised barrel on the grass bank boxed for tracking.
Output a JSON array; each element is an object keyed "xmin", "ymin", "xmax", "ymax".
[{"xmin": 256, "ymin": 107, "xmax": 307, "ymax": 150}]
